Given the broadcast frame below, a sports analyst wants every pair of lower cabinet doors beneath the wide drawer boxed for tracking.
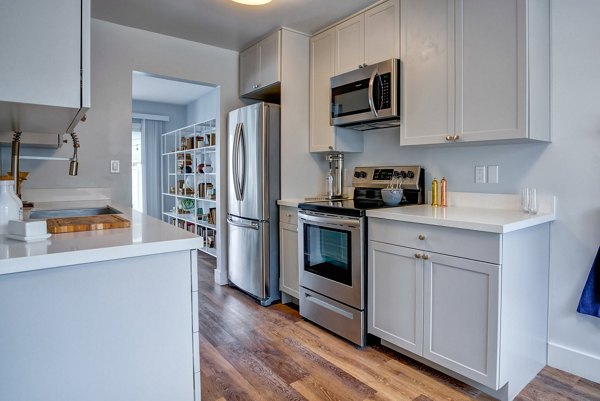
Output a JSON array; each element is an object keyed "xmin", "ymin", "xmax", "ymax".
[{"xmin": 369, "ymin": 241, "xmax": 500, "ymax": 388}]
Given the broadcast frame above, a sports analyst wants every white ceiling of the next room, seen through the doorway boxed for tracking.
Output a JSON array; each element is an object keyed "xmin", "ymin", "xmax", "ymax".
[{"xmin": 131, "ymin": 71, "xmax": 214, "ymax": 105}]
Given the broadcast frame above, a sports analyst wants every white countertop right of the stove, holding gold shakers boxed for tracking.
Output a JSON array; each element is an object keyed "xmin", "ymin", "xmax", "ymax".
[{"xmin": 367, "ymin": 193, "xmax": 556, "ymax": 234}]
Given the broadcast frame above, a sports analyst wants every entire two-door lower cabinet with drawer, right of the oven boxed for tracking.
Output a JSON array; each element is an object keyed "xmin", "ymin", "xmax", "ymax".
[{"xmin": 367, "ymin": 218, "xmax": 549, "ymax": 400}]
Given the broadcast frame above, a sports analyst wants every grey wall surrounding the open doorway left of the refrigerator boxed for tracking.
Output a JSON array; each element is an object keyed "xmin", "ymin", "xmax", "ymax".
[{"xmin": 19, "ymin": 20, "xmax": 241, "ymax": 205}]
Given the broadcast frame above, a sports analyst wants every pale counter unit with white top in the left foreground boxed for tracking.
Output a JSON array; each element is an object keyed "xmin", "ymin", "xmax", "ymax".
[{"xmin": 0, "ymin": 203, "xmax": 201, "ymax": 401}]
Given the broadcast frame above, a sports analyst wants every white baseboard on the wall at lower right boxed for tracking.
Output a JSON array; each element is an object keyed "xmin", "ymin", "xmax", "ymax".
[{"xmin": 548, "ymin": 342, "xmax": 600, "ymax": 383}]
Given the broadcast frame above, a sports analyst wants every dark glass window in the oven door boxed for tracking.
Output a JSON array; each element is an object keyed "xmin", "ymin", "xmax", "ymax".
[{"xmin": 304, "ymin": 223, "xmax": 352, "ymax": 286}]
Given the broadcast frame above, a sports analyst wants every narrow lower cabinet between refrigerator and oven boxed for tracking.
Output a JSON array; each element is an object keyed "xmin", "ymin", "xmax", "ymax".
[{"xmin": 279, "ymin": 206, "xmax": 300, "ymax": 299}]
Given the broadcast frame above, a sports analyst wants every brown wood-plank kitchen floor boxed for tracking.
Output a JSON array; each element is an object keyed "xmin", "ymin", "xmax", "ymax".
[{"xmin": 199, "ymin": 259, "xmax": 600, "ymax": 401}]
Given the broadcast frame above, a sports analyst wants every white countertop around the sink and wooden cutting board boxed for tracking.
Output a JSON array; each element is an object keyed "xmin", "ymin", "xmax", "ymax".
[{"xmin": 0, "ymin": 201, "xmax": 202, "ymax": 275}]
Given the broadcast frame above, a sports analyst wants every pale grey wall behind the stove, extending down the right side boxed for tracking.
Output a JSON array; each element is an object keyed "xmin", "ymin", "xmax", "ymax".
[{"xmin": 346, "ymin": 0, "xmax": 600, "ymax": 382}]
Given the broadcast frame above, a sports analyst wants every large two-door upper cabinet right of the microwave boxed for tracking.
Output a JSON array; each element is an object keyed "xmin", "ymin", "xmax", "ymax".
[{"xmin": 400, "ymin": 0, "xmax": 550, "ymax": 145}]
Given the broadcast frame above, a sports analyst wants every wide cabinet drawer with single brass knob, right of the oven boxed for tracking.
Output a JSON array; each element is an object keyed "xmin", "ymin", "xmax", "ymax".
[{"xmin": 369, "ymin": 218, "xmax": 502, "ymax": 264}]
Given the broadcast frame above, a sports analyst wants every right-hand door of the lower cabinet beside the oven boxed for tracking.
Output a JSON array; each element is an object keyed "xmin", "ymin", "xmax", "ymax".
[{"xmin": 423, "ymin": 253, "xmax": 500, "ymax": 389}]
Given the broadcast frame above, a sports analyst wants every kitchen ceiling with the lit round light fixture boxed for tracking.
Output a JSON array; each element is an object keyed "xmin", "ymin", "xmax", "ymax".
[{"xmin": 92, "ymin": 0, "xmax": 377, "ymax": 51}]
